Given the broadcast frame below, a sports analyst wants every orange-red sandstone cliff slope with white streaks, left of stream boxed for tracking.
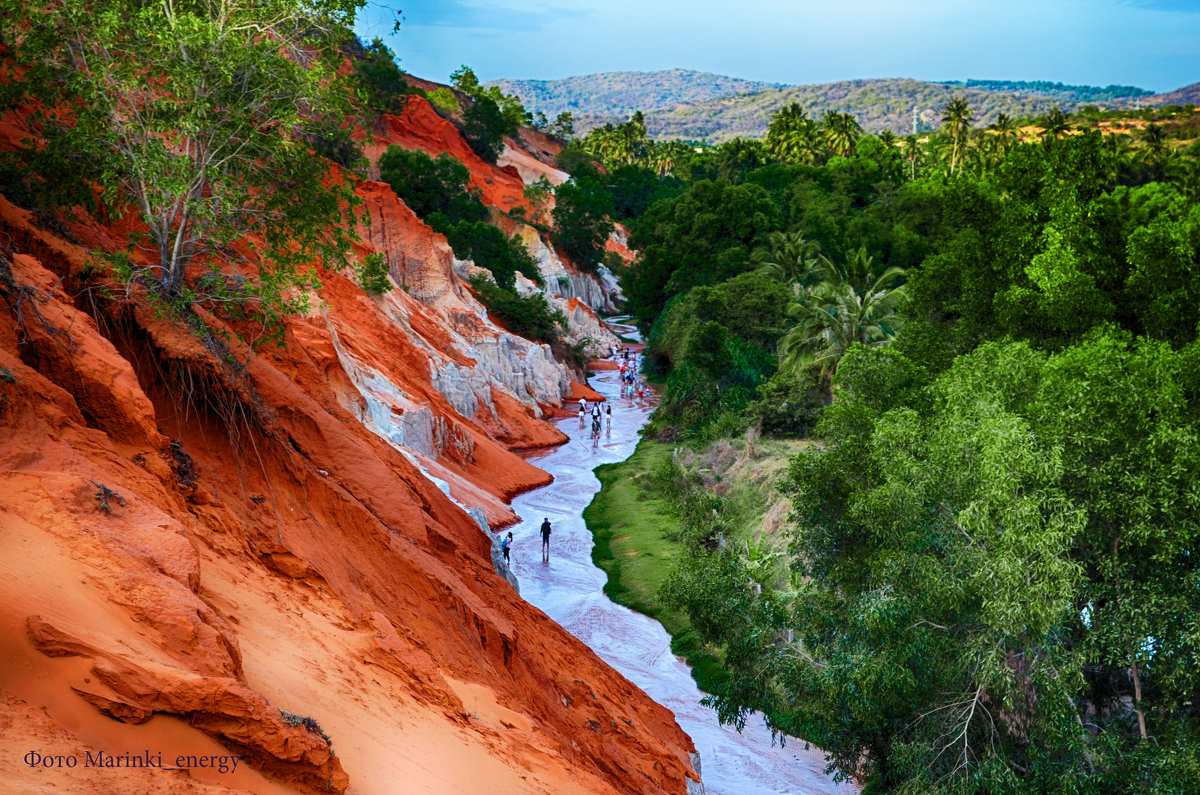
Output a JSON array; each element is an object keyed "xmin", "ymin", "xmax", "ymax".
[{"xmin": 0, "ymin": 79, "xmax": 695, "ymax": 793}]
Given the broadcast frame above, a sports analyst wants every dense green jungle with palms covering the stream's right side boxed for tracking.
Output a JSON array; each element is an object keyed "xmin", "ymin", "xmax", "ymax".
[{"xmin": 600, "ymin": 98, "xmax": 1200, "ymax": 793}]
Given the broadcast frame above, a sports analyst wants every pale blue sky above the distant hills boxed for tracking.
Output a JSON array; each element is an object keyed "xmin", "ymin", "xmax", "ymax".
[{"xmin": 358, "ymin": 0, "xmax": 1200, "ymax": 91}]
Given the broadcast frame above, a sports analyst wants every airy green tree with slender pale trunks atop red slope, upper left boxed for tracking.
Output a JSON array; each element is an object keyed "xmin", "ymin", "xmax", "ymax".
[{"xmin": 0, "ymin": 0, "xmax": 362, "ymax": 329}]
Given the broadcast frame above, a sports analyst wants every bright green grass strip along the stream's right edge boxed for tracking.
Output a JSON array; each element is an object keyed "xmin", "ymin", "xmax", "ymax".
[{"xmin": 583, "ymin": 440, "xmax": 724, "ymax": 689}]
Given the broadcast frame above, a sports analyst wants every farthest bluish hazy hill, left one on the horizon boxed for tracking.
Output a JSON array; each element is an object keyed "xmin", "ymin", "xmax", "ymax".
[{"xmin": 487, "ymin": 68, "xmax": 786, "ymax": 120}]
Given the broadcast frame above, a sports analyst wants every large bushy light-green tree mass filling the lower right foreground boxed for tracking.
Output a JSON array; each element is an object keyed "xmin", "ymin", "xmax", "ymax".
[{"xmin": 670, "ymin": 331, "xmax": 1200, "ymax": 794}]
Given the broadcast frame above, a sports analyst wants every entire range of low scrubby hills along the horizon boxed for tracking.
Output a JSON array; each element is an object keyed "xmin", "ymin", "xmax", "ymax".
[{"xmin": 493, "ymin": 70, "xmax": 1171, "ymax": 143}]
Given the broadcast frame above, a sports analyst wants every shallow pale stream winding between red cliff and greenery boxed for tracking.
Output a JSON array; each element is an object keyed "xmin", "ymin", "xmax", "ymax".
[{"xmin": 511, "ymin": 326, "xmax": 856, "ymax": 795}]
